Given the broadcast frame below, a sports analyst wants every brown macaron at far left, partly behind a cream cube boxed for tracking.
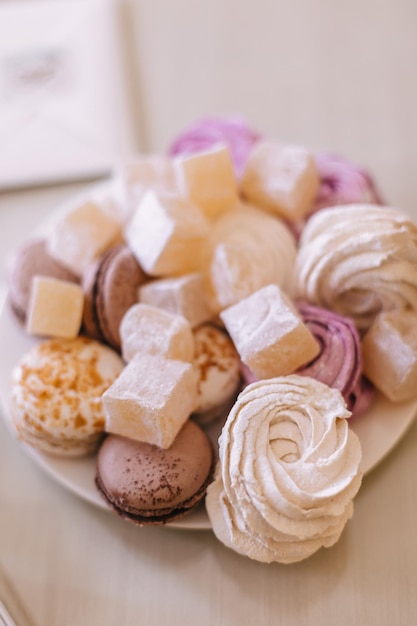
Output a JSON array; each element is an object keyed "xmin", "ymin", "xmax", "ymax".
[{"xmin": 9, "ymin": 238, "xmax": 79, "ymax": 323}]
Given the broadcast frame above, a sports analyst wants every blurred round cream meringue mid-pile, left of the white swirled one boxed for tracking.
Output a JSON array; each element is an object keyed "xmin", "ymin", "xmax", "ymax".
[{"xmin": 202, "ymin": 204, "xmax": 296, "ymax": 314}]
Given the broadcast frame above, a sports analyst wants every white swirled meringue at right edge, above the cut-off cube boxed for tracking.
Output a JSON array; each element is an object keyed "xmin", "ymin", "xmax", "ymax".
[{"xmin": 294, "ymin": 204, "xmax": 417, "ymax": 332}]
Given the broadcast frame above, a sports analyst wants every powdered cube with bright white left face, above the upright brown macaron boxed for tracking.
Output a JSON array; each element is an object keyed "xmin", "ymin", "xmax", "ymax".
[{"xmin": 126, "ymin": 191, "xmax": 209, "ymax": 276}]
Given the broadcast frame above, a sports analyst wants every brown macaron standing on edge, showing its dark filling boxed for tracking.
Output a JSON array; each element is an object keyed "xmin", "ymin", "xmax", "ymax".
[{"xmin": 83, "ymin": 244, "xmax": 146, "ymax": 350}]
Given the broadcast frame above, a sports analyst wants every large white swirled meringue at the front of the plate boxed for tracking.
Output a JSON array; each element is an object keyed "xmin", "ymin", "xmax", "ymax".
[{"xmin": 206, "ymin": 375, "xmax": 362, "ymax": 563}]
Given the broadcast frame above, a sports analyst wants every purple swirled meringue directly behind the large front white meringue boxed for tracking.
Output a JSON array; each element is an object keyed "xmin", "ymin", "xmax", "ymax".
[{"xmin": 297, "ymin": 302, "xmax": 373, "ymax": 415}]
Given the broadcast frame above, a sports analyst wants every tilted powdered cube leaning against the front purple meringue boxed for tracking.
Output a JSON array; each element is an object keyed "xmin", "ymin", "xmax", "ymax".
[{"xmin": 220, "ymin": 285, "xmax": 320, "ymax": 378}]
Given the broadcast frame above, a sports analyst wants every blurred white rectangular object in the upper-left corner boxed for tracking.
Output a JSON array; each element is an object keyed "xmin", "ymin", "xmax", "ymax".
[{"xmin": 0, "ymin": 0, "xmax": 140, "ymax": 189}]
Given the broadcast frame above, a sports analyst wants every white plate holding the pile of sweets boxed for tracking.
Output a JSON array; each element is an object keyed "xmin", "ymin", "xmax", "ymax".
[{"xmin": 0, "ymin": 294, "xmax": 417, "ymax": 530}]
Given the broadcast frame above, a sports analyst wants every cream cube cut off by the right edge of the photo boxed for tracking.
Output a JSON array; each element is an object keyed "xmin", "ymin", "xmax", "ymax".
[{"xmin": 362, "ymin": 309, "xmax": 417, "ymax": 402}]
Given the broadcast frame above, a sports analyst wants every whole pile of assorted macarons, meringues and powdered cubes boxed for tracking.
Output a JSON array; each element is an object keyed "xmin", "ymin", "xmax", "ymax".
[{"xmin": 4, "ymin": 118, "xmax": 417, "ymax": 563}]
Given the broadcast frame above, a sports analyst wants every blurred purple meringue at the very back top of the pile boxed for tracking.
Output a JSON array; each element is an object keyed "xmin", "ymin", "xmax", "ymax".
[{"xmin": 168, "ymin": 116, "xmax": 261, "ymax": 178}]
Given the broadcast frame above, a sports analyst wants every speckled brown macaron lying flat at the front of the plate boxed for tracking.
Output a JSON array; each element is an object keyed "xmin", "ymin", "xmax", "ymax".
[{"xmin": 96, "ymin": 420, "xmax": 214, "ymax": 526}]
